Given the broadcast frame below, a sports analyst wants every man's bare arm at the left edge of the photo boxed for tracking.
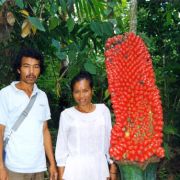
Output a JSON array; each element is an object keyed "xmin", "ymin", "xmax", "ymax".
[{"xmin": 0, "ymin": 124, "xmax": 8, "ymax": 180}]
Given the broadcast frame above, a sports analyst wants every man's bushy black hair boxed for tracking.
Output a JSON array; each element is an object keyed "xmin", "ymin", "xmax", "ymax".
[{"xmin": 13, "ymin": 48, "xmax": 44, "ymax": 78}]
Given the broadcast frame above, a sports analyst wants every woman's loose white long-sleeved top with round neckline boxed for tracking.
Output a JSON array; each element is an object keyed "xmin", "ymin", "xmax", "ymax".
[{"xmin": 55, "ymin": 104, "xmax": 112, "ymax": 180}]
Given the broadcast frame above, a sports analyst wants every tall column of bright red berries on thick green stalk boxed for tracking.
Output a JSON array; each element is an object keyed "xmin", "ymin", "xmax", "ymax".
[{"xmin": 105, "ymin": 33, "xmax": 164, "ymax": 162}]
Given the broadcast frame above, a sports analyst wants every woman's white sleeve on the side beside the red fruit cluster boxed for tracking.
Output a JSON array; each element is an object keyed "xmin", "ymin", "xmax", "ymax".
[{"xmin": 104, "ymin": 106, "xmax": 113, "ymax": 164}]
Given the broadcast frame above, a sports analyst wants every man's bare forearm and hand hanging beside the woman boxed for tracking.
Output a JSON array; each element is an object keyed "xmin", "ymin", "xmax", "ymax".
[{"xmin": 43, "ymin": 122, "xmax": 57, "ymax": 180}]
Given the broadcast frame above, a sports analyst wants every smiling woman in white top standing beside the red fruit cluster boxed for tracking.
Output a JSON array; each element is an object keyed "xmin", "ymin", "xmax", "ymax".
[{"xmin": 55, "ymin": 72, "xmax": 116, "ymax": 180}]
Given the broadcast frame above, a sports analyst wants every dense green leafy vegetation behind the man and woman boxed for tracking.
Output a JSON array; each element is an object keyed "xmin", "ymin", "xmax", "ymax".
[{"xmin": 0, "ymin": 0, "xmax": 180, "ymax": 180}]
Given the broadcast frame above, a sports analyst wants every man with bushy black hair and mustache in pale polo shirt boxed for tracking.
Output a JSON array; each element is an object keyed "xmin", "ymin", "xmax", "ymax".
[{"xmin": 0, "ymin": 49, "xmax": 57, "ymax": 180}]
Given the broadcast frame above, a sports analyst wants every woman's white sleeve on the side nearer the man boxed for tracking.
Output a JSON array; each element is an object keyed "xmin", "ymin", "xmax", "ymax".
[{"xmin": 55, "ymin": 112, "xmax": 69, "ymax": 167}]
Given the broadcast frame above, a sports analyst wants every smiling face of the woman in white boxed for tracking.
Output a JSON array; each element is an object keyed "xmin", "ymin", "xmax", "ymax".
[{"xmin": 73, "ymin": 79, "xmax": 92, "ymax": 106}]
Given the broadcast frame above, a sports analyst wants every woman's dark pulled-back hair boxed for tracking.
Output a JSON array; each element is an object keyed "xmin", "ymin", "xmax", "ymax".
[{"xmin": 71, "ymin": 71, "xmax": 93, "ymax": 92}]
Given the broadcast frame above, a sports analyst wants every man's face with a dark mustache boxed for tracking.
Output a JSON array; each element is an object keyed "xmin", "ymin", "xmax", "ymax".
[{"xmin": 17, "ymin": 57, "xmax": 40, "ymax": 84}]
